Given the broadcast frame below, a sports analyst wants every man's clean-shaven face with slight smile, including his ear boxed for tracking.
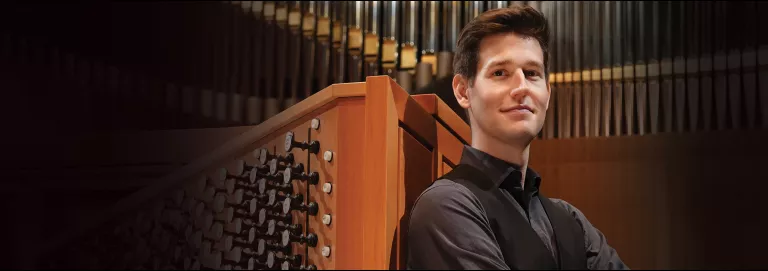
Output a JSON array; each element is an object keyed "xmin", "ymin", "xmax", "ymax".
[{"xmin": 454, "ymin": 33, "xmax": 550, "ymax": 144}]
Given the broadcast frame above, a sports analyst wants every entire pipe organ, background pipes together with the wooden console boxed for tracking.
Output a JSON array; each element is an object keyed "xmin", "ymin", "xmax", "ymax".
[{"xmin": 0, "ymin": 1, "xmax": 768, "ymax": 270}]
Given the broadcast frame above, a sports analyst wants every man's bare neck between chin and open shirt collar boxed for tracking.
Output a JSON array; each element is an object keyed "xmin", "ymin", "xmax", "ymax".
[{"xmin": 472, "ymin": 135, "xmax": 530, "ymax": 187}]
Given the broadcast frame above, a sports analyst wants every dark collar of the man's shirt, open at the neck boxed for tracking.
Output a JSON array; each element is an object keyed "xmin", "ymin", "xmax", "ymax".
[{"xmin": 459, "ymin": 145, "xmax": 541, "ymax": 191}]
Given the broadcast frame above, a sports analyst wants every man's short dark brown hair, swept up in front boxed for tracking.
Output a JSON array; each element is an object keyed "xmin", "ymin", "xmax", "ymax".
[{"xmin": 453, "ymin": 5, "xmax": 550, "ymax": 85}]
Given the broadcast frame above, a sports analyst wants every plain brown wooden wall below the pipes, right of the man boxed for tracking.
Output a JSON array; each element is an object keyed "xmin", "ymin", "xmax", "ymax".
[{"xmin": 530, "ymin": 131, "xmax": 768, "ymax": 269}]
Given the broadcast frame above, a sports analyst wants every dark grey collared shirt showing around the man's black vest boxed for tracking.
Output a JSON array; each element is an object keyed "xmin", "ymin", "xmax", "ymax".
[{"xmin": 408, "ymin": 146, "xmax": 628, "ymax": 269}]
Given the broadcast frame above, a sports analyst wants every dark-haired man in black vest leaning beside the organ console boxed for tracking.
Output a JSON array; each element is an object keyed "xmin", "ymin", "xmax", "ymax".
[{"xmin": 408, "ymin": 6, "xmax": 628, "ymax": 269}]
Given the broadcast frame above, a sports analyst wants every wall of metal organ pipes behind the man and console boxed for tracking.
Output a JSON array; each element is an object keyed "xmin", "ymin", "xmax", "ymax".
[{"xmin": 3, "ymin": 1, "xmax": 768, "ymax": 139}]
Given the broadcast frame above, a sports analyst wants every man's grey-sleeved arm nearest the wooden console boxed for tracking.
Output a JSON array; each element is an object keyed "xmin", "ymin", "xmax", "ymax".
[{"xmin": 408, "ymin": 180, "xmax": 509, "ymax": 270}]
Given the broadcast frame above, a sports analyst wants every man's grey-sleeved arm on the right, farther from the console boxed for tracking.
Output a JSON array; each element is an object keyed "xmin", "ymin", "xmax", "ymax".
[{"xmin": 551, "ymin": 199, "xmax": 629, "ymax": 270}]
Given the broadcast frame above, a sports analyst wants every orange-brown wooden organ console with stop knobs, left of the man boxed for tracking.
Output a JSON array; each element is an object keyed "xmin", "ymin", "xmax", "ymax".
[{"xmin": 41, "ymin": 76, "xmax": 469, "ymax": 270}]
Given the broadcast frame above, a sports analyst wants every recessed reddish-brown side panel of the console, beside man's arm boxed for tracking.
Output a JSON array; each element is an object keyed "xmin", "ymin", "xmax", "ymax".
[{"xmin": 389, "ymin": 129, "xmax": 434, "ymax": 270}]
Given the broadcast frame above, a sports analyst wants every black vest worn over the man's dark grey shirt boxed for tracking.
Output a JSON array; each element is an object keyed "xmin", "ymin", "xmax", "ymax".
[{"xmin": 440, "ymin": 164, "xmax": 587, "ymax": 269}]
